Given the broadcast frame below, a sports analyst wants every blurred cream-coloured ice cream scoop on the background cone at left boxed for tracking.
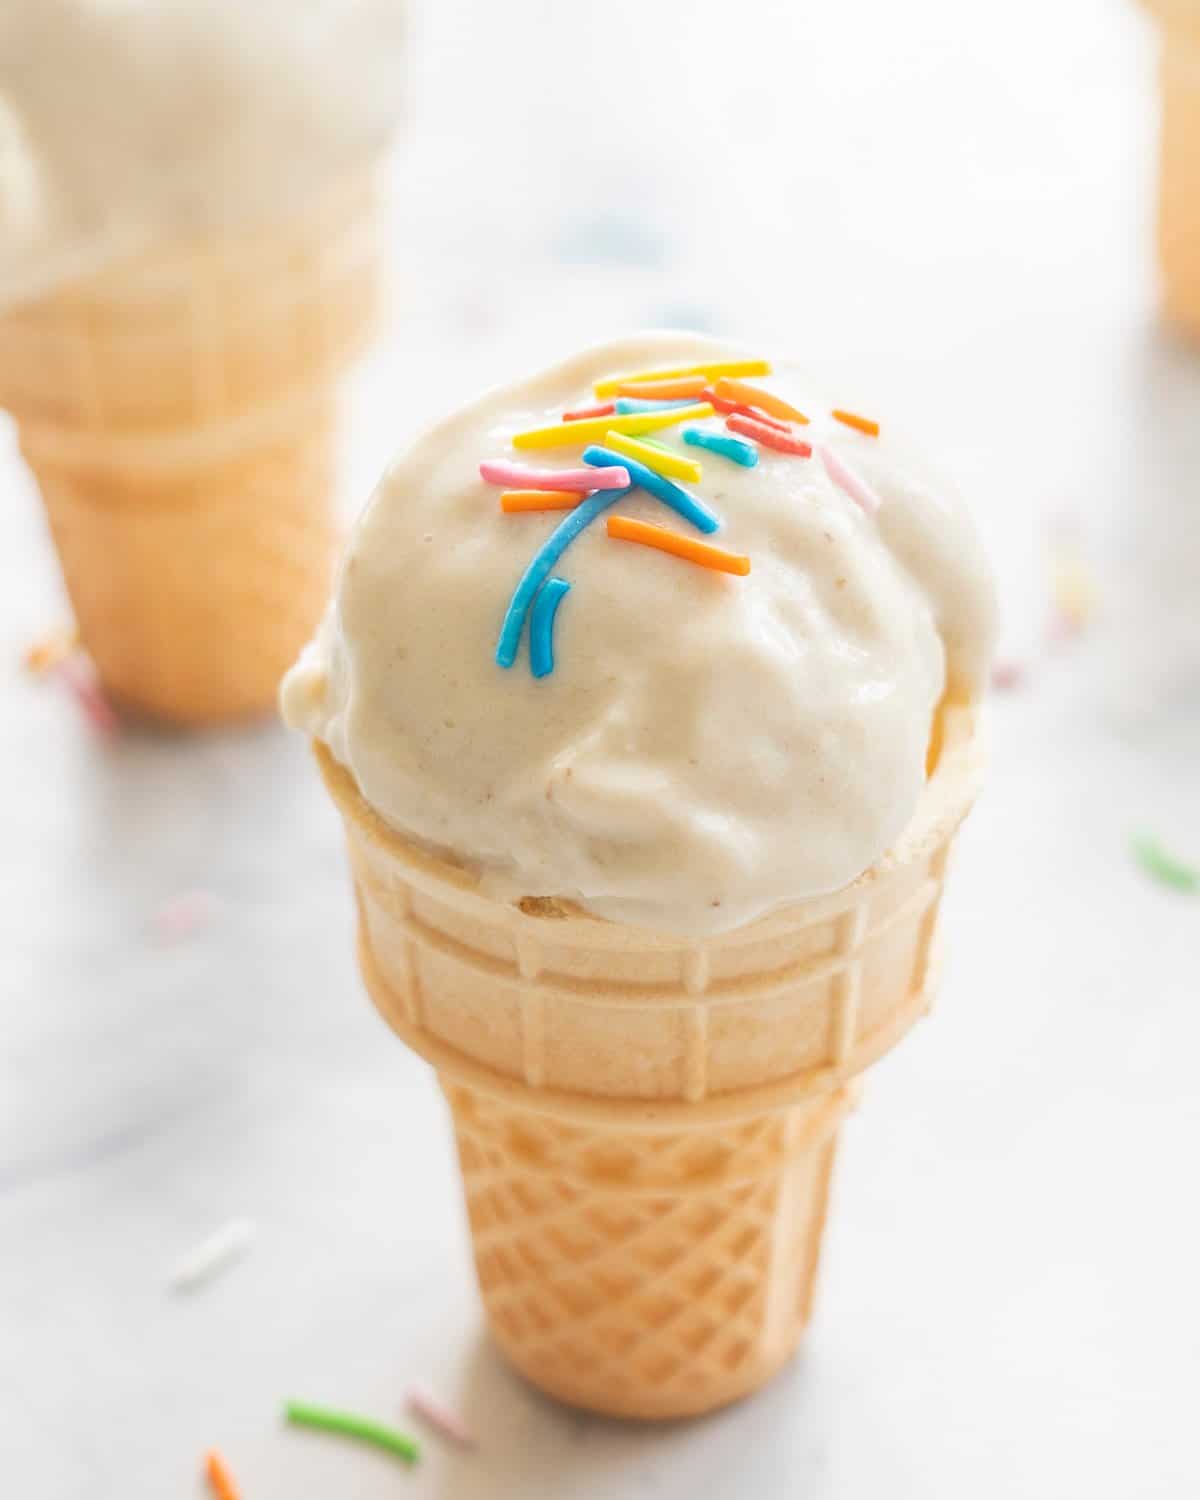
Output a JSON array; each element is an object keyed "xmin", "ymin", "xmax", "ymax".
[{"xmin": 0, "ymin": 0, "xmax": 405, "ymax": 300}]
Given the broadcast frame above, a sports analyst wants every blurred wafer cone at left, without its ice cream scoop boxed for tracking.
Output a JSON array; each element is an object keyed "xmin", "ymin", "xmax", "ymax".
[{"xmin": 0, "ymin": 179, "xmax": 380, "ymax": 723}]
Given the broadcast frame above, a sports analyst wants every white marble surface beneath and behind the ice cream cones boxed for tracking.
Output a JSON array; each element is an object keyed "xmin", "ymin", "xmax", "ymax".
[{"xmin": 0, "ymin": 0, "xmax": 1200, "ymax": 1500}]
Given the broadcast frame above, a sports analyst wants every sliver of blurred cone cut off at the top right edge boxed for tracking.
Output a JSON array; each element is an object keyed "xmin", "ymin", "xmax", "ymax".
[{"xmin": 1146, "ymin": 0, "xmax": 1200, "ymax": 339}]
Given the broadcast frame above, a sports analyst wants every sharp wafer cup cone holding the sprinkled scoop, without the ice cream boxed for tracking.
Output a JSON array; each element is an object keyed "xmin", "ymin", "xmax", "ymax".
[{"xmin": 318, "ymin": 710, "xmax": 980, "ymax": 1418}]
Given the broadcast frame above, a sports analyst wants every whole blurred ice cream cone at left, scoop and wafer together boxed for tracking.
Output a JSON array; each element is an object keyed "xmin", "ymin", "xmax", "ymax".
[{"xmin": 0, "ymin": 0, "xmax": 399, "ymax": 723}]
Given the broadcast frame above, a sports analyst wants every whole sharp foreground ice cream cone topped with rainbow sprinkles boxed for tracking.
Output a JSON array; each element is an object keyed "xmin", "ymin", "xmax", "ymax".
[{"xmin": 284, "ymin": 335, "xmax": 992, "ymax": 1418}]
